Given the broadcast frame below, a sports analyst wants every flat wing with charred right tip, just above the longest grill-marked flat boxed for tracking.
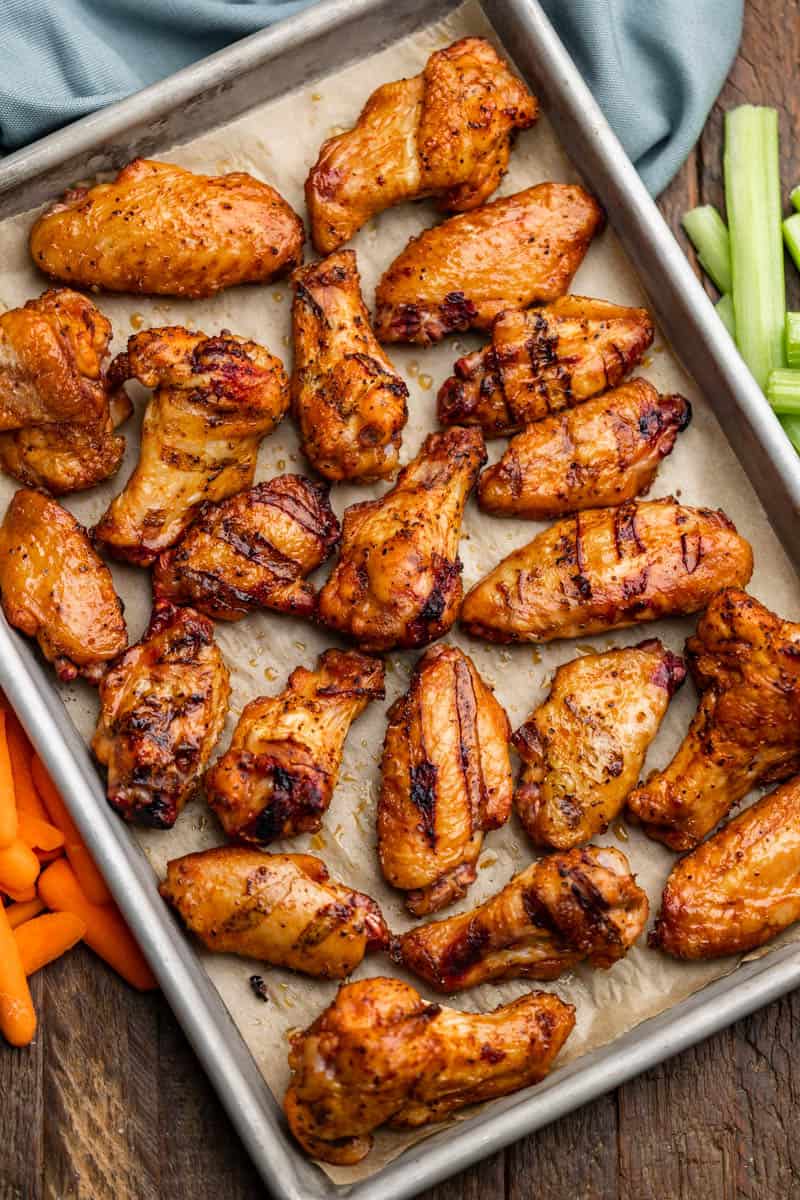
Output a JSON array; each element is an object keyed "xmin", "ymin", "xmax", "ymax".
[{"xmin": 477, "ymin": 379, "xmax": 692, "ymax": 520}]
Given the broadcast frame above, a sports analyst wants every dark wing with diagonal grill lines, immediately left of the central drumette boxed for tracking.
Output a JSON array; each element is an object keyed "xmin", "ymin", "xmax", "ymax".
[{"xmin": 152, "ymin": 475, "xmax": 339, "ymax": 620}]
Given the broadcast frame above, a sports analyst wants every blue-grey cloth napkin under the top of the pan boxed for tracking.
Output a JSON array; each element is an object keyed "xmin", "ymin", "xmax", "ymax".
[{"xmin": 0, "ymin": 0, "xmax": 742, "ymax": 194}]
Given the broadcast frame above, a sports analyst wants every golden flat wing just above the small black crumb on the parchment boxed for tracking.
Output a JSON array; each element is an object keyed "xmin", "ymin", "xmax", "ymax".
[{"xmin": 158, "ymin": 846, "xmax": 389, "ymax": 979}]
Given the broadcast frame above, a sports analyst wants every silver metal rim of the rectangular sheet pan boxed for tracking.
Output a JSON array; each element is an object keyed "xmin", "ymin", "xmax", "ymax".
[{"xmin": 0, "ymin": 0, "xmax": 800, "ymax": 1200}]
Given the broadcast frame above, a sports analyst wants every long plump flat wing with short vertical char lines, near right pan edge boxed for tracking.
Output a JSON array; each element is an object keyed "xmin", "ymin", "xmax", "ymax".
[{"xmin": 461, "ymin": 497, "xmax": 753, "ymax": 642}]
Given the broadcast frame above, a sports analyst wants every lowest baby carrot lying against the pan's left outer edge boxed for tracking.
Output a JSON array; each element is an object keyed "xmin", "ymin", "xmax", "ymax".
[{"xmin": 38, "ymin": 858, "xmax": 158, "ymax": 991}]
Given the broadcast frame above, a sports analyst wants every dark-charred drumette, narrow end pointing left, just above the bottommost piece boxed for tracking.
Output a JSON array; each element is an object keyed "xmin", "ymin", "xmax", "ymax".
[{"xmin": 391, "ymin": 846, "xmax": 649, "ymax": 992}]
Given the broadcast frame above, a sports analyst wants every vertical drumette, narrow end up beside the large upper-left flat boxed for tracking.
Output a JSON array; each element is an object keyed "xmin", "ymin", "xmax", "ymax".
[{"xmin": 291, "ymin": 250, "xmax": 408, "ymax": 481}]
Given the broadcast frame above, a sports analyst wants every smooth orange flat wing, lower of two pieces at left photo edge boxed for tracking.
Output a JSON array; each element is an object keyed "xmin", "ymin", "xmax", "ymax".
[{"xmin": 0, "ymin": 491, "xmax": 128, "ymax": 683}]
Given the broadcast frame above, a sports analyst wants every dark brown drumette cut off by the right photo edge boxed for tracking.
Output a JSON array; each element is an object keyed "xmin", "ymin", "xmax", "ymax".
[{"xmin": 627, "ymin": 588, "xmax": 800, "ymax": 850}]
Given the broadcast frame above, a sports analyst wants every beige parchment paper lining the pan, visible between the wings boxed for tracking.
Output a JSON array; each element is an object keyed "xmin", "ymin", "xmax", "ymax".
[{"xmin": 0, "ymin": 5, "xmax": 800, "ymax": 1182}]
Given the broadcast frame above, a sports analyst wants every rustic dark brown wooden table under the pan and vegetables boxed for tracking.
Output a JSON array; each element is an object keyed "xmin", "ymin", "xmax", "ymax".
[{"xmin": 0, "ymin": 0, "xmax": 800, "ymax": 1200}]
